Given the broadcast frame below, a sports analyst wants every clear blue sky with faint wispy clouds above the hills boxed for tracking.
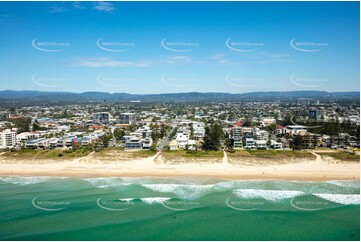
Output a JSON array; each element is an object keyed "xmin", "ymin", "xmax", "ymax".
[{"xmin": 0, "ymin": 2, "xmax": 360, "ymax": 93}]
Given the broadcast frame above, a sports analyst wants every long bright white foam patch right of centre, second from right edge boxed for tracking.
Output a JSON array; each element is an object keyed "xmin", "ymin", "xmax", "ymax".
[{"xmin": 233, "ymin": 189, "xmax": 304, "ymax": 201}]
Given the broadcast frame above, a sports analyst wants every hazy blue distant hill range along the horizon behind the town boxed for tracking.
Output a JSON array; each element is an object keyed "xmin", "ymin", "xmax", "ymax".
[{"xmin": 0, "ymin": 90, "xmax": 360, "ymax": 102}]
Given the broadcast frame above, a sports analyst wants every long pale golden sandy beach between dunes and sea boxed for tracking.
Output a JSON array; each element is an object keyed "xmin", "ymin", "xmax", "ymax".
[{"xmin": 0, "ymin": 150, "xmax": 360, "ymax": 181}]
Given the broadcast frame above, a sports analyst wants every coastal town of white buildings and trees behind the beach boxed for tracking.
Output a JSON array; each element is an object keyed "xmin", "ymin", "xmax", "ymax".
[{"xmin": 0, "ymin": 98, "xmax": 360, "ymax": 161}]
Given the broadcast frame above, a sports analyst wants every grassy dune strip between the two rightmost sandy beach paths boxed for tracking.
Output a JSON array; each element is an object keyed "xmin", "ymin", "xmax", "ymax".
[{"xmin": 227, "ymin": 150, "xmax": 316, "ymax": 159}]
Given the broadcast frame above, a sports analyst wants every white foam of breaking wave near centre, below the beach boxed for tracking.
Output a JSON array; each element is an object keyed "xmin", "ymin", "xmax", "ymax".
[{"xmin": 142, "ymin": 184, "xmax": 214, "ymax": 199}]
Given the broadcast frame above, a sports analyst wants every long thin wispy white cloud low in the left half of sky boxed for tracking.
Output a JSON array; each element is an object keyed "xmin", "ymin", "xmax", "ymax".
[{"xmin": 75, "ymin": 58, "xmax": 151, "ymax": 67}]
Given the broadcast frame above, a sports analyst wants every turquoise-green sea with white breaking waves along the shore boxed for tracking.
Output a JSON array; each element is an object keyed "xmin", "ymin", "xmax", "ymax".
[{"xmin": 0, "ymin": 177, "xmax": 360, "ymax": 240}]
